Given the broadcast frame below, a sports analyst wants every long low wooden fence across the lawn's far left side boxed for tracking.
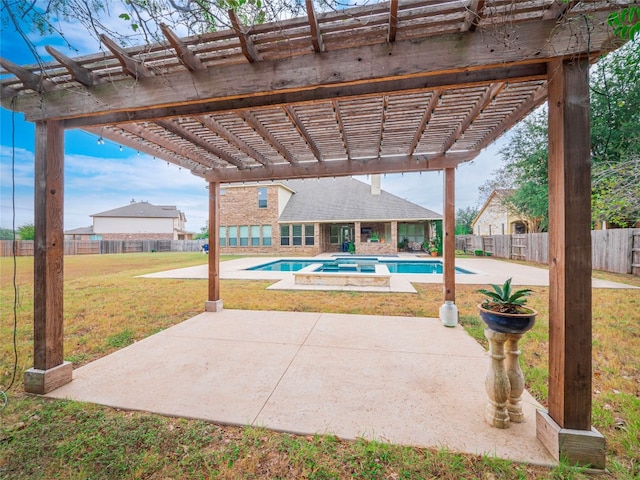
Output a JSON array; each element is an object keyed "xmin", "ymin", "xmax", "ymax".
[{"xmin": 0, "ymin": 240, "xmax": 207, "ymax": 257}]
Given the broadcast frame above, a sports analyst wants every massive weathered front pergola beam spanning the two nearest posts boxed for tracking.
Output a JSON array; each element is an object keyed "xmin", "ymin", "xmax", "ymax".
[{"xmin": 8, "ymin": 12, "xmax": 610, "ymax": 120}]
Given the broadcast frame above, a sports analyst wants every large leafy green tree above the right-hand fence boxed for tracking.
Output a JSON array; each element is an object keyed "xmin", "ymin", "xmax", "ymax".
[{"xmin": 480, "ymin": 38, "xmax": 640, "ymax": 231}]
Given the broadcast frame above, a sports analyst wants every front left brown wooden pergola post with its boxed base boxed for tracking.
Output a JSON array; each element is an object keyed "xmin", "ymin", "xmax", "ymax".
[{"xmin": 24, "ymin": 121, "xmax": 73, "ymax": 394}]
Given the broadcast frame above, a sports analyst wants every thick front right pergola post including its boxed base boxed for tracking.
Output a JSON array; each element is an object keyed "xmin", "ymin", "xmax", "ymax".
[{"xmin": 536, "ymin": 58, "xmax": 605, "ymax": 468}]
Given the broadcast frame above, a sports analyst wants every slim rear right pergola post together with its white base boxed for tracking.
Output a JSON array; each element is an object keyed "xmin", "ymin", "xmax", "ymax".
[{"xmin": 440, "ymin": 168, "xmax": 458, "ymax": 326}]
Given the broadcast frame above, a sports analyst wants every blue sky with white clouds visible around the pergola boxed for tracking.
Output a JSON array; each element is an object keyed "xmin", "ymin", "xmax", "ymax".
[{"xmin": 0, "ymin": 5, "xmax": 506, "ymax": 233}]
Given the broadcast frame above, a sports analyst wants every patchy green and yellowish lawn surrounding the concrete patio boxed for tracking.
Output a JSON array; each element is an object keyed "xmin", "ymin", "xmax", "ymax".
[{"xmin": 0, "ymin": 253, "xmax": 640, "ymax": 479}]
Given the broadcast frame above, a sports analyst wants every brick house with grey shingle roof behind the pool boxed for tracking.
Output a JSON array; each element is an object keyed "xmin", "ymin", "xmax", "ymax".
[{"xmin": 218, "ymin": 176, "xmax": 442, "ymax": 255}]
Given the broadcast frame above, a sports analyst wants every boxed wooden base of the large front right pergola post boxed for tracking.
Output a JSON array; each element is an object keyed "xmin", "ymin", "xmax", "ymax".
[{"xmin": 536, "ymin": 410, "xmax": 606, "ymax": 470}]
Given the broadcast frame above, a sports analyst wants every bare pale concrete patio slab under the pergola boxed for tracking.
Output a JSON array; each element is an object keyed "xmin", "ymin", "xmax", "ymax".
[{"xmin": 48, "ymin": 310, "xmax": 554, "ymax": 465}]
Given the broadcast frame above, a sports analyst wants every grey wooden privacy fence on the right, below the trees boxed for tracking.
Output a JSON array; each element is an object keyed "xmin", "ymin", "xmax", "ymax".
[{"xmin": 456, "ymin": 228, "xmax": 640, "ymax": 275}]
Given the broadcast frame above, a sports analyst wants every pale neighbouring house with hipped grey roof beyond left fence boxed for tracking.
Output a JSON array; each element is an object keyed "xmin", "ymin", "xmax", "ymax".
[{"xmin": 65, "ymin": 200, "xmax": 193, "ymax": 240}]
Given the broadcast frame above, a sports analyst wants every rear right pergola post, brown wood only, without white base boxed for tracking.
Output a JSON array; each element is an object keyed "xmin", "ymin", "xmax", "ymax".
[{"xmin": 442, "ymin": 168, "xmax": 456, "ymax": 302}]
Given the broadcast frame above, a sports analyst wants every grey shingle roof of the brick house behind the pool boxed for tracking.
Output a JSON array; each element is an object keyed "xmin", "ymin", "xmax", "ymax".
[{"xmin": 279, "ymin": 177, "xmax": 442, "ymax": 222}]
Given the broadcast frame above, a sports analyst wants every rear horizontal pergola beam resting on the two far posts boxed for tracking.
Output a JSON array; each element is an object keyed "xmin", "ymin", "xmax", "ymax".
[{"xmin": 205, "ymin": 153, "xmax": 476, "ymax": 183}]
